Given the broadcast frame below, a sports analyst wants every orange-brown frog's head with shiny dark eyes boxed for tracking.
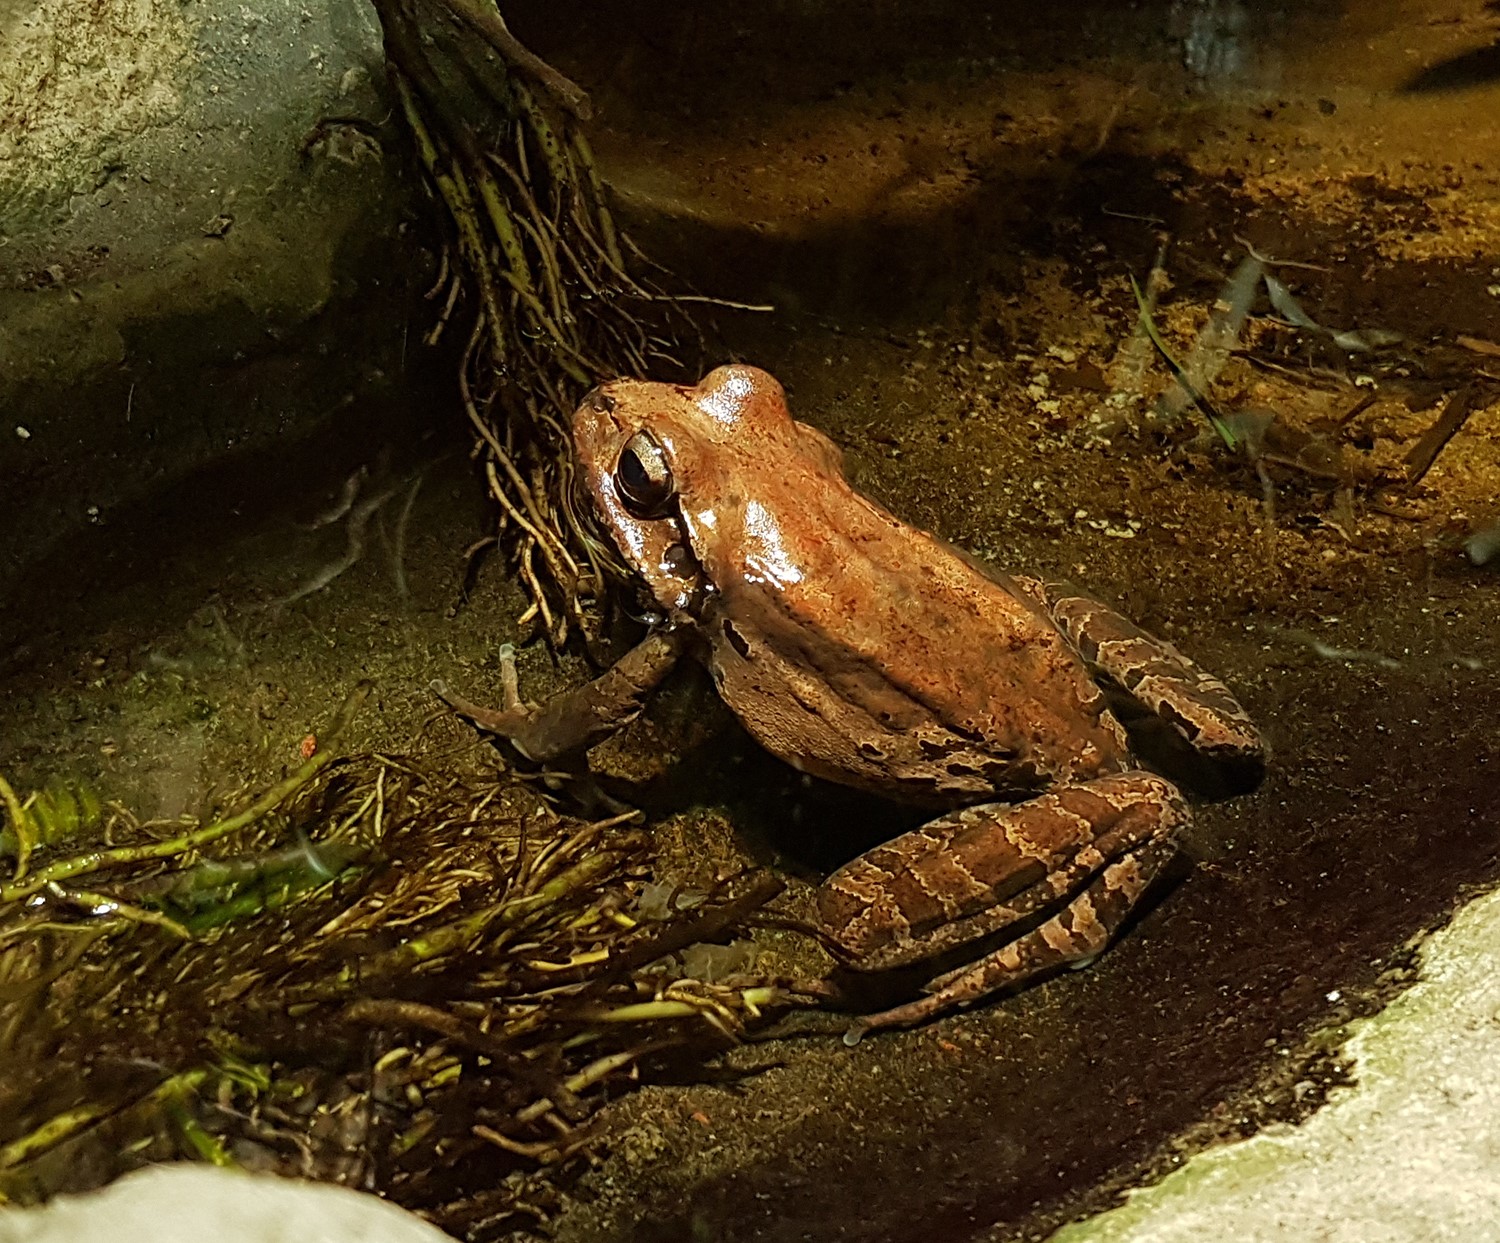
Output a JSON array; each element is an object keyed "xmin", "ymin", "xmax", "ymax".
[{"xmin": 573, "ymin": 364, "xmax": 840, "ymax": 613}]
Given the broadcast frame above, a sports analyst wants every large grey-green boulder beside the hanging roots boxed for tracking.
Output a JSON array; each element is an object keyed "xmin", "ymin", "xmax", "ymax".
[{"xmin": 0, "ymin": 0, "xmax": 422, "ymax": 598}]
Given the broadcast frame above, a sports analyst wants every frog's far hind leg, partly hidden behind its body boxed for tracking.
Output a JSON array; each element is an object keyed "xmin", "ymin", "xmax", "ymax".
[{"xmin": 1044, "ymin": 583, "xmax": 1262, "ymax": 759}]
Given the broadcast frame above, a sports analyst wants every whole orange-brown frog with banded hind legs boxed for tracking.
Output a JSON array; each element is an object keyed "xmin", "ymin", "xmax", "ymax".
[{"xmin": 438, "ymin": 366, "xmax": 1260, "ymax": 1035}]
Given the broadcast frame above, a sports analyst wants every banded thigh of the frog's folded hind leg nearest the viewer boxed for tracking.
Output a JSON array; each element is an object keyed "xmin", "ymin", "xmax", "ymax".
[{"xmin": 818, "ymin": 771, "xmax": 1190, "ymax": 970}]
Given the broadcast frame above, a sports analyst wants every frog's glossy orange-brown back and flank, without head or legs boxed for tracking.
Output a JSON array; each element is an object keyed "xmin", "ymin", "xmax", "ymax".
[{"xmin": 687, "ymin": 455, "xmax": 1124, "ymax": 805}]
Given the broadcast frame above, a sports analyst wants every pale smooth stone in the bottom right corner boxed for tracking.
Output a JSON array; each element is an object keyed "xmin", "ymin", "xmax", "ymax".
[{"xmin": 1053, "ymin": 894, "xmax": 1500, "ymax": 1243}]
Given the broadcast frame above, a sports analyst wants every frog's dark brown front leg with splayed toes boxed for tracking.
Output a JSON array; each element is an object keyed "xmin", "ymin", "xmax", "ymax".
[{"xmin": 432, "ymin": 628, "xmax": 690, "ymax": 763}]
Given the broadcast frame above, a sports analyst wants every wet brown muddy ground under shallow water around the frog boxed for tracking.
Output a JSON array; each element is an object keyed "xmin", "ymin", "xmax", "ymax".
[{"xmin": 0, "ymin": 3, "xmax": 1500, "ymax": 1240}]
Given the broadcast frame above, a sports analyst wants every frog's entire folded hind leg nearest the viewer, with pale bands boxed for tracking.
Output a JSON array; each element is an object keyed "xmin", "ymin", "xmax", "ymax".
[{"xmin": 818, "ymin": 771, "xmax": 1190, "ymax": 1044}]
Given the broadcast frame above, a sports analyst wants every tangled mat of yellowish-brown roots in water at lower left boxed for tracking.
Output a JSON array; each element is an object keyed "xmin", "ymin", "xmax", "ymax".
[{"xmin": 0, "ymin": 689, "xmax": 789, "ymax": 1233}]
